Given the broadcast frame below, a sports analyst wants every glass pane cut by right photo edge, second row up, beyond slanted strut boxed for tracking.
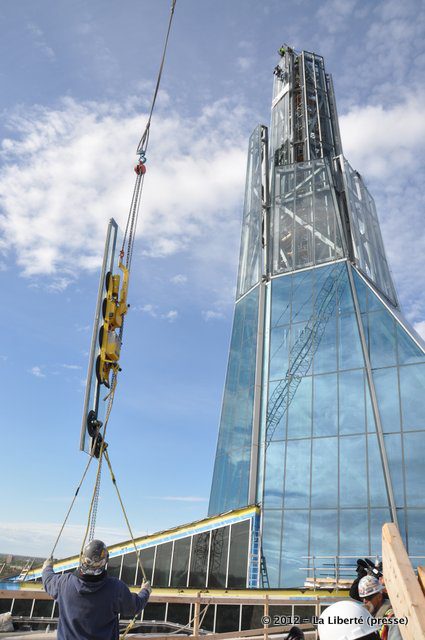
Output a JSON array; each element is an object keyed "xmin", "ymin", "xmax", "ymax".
[{"xmin": 403, "ymin": 431, "xmax": 425, "ymax": 508}]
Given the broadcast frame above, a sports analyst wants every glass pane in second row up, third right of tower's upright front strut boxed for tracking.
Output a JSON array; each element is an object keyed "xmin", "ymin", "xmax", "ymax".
[{"xmin": 311, "ymin": 438, "xmax": 338, "ymax": 509}]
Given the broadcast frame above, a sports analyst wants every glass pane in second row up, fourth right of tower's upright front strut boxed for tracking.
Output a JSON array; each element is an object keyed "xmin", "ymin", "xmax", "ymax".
[{"xmin": 339, "ymin": 436, "xmax": 367, "ymax": 507}]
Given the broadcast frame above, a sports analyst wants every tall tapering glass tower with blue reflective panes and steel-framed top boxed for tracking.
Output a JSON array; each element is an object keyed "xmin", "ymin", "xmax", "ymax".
[{"xmin": 209, "ymin": 47, "xmax": 425, "ymax": 588}]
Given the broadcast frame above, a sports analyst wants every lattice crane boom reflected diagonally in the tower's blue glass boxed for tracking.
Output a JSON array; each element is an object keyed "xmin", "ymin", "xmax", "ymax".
[{"xmin": 266, "ymin": 264, "xmax": 345, "ymax": 447}]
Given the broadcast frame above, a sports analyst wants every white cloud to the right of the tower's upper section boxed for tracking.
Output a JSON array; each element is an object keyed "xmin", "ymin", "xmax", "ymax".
[{"xmin": 340, "ymin": 91, "xmax": 425, "ymax": 323}]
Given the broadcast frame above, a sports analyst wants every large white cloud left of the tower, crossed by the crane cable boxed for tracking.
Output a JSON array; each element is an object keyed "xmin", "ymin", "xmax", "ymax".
[{"xmin": 0, "ymin": 98, "xmax": 246, "ymax": 290}]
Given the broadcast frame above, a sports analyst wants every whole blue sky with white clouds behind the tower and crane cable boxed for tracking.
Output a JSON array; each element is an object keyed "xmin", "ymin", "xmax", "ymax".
[{"xmin": 0, "ymin": 0, "xmax": 425, "ymax": 556}]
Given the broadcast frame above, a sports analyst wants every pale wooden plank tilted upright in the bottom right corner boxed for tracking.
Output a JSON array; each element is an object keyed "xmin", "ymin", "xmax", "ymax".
[{"xmin": 382, "ymin": 523, "xmax": 425, "ymax": 640}]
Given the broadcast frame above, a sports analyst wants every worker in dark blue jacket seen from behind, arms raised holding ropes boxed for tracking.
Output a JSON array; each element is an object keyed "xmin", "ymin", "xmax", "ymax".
[{"xmin": 42, "ymin": 540, "xmax": 151, "ymax": 640}]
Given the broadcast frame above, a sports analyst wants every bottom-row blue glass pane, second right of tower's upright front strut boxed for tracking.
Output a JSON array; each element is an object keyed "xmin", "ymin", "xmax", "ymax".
[{"xmin": 282, "ymin": 510, "xmax": 308, "ymax": 587}]
